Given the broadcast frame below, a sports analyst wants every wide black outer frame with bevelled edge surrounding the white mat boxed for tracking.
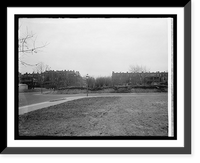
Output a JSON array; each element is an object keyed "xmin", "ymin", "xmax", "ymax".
[{"xmin": 1, "ymin": 1, "xmax": 194, "ymax": 156}]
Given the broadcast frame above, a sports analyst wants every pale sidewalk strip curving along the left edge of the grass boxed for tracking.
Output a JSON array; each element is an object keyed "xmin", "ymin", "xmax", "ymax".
[{"xmin": 19, "ymin": 96, "xmax": 94, "ymax": 115}]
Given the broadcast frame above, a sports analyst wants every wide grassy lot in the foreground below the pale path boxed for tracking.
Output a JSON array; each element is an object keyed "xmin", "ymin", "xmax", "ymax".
[{"xmin": 19, "ymin": 93, "xmax": 168, "ymax": 136}]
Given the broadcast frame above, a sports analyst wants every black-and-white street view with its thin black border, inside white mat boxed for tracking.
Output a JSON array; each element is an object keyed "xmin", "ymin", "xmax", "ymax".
[{"xmin": 15, "ymin": 15, "xmax": 174, "ymax": 139}]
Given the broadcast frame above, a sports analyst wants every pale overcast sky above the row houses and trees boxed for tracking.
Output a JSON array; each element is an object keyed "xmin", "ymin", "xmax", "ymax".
[{"xmin": 19, "ymin": 18, "xmax": 169, "ymax": 77}]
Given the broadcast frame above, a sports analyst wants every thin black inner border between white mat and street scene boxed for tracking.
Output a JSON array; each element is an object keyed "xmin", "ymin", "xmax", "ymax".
[{"xmin": 14, "ymin": 14, "xmax": 177, "ymax": 140}]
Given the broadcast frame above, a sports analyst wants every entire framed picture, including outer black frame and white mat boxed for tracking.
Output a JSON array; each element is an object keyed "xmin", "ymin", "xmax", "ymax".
[{"xmin": 0, "ymin": 3, "xmax": 194, "ymax": 157}]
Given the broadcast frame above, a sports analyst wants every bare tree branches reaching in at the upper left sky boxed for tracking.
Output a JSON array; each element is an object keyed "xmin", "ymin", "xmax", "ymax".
[{"xmin": 18, "ymin": 26, "xmax": 48, "ymax": 66}]
